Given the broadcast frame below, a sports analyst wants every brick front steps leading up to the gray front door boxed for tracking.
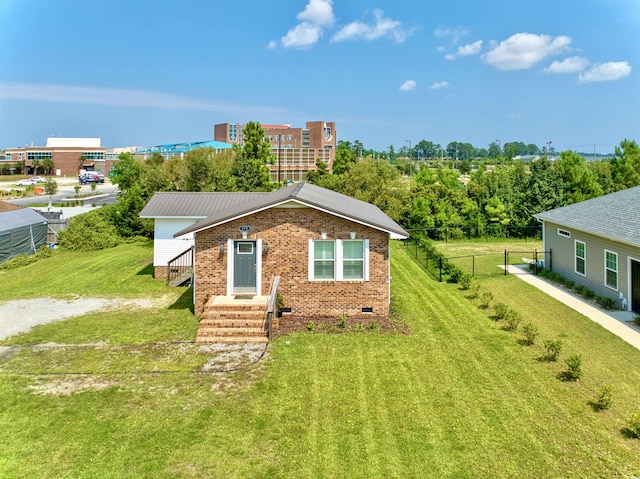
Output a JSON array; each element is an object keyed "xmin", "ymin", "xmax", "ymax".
[{"xmin": 196, "ymin": 295, "xmax": 269, "ymax": 343}]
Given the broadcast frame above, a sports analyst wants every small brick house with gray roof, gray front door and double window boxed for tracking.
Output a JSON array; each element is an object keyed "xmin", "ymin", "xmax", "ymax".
[{"xmin": 141, "ymin": 182, "xmax": 408, "ymax": 328}]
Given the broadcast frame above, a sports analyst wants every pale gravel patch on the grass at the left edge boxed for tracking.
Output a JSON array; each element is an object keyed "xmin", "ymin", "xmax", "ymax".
[{"xmin": 0, "ymin": 298, "xmax": 154, "ymax": 339}]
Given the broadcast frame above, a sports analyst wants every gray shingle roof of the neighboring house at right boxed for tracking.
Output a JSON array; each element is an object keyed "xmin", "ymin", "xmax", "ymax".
[{"xmin": 534, "ymin": 186, "xmax": 640, "ymax": 246}]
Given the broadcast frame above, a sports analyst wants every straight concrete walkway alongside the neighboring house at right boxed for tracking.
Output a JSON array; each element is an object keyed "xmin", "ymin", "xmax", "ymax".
[{"xmin": 508, "ymin": 265, "xmax": 640, "ymax": 349}]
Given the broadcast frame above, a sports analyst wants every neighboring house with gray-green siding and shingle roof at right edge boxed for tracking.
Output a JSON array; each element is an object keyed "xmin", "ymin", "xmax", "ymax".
[{"xmin": 534, "ymin": 186, "xmax": 640, "ymax": 313}]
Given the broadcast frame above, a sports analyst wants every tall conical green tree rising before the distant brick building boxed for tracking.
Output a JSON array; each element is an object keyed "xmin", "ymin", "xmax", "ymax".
[{"xmin": 232, "ymin": 121, "xmax": 274, "ymax": 191}]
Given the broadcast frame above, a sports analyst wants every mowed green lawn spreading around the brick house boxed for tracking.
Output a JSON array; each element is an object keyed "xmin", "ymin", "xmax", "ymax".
[{"xmin": 0, "ymin": 242, "xmax": 640, "ymax": 478}]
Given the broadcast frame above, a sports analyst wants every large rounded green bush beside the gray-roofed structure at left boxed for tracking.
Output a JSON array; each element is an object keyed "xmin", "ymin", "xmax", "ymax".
[{"xmin": 58, "ymin": 209, "xmax": 121, "ymax": 251}]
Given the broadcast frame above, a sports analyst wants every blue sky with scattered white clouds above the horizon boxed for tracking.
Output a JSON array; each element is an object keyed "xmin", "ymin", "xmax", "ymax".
[{"xmin": 0, "ymin": 0, "xmax": 640, "ymax": 153}]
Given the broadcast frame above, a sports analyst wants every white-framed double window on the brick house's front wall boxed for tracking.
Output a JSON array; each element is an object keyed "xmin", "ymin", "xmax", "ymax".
[{"xmin": 309, "ymin": 239, "xmax": 369, "ymax": 281}]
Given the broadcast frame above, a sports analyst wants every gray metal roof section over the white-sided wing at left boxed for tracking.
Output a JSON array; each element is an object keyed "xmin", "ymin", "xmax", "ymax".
[{"xmin": 140, "ymin": 192, "xmax": 268, "ymax": 218}]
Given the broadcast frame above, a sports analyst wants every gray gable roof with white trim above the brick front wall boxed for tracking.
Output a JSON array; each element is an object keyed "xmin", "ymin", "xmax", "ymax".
[{"xmin": 169, "ymin": 182, "xmax": 409, "ymax": 239}]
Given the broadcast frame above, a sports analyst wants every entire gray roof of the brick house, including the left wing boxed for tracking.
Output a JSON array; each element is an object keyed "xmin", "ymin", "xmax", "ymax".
[{"xmin": 140, "ymin": 182, "xmax": 409, "ymax": 238}]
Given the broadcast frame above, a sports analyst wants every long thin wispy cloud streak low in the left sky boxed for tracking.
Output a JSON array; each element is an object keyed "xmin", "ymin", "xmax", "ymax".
[{"xmin": 0, "ymin": 82, "xmax": 291, "ymax": 115}]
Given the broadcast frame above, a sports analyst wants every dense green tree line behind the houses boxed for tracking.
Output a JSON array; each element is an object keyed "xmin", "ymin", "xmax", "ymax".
[{"xmin": 67, "ymin": 122, "xmax": 640, "ymax": 251}]
